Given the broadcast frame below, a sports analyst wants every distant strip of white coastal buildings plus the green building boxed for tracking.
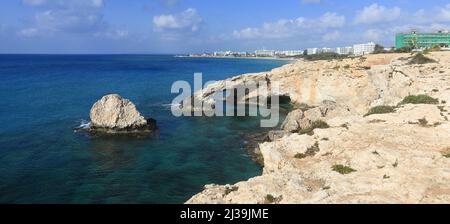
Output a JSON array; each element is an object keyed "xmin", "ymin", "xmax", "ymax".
[{"xmin": 183, "ymin": 30, "xmax": 450, "ymax": 58}]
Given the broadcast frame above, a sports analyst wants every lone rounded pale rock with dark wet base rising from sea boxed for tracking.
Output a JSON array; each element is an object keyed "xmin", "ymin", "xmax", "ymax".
[{"xmin": 89, "ymin": 94, "xmax": 157, "ymax": 135}]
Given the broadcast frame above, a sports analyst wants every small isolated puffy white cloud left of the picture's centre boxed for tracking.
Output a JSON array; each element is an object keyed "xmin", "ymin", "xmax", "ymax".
[{"xmin": 153, "ymin": 8, "xmax": 202, "ymax": 32}]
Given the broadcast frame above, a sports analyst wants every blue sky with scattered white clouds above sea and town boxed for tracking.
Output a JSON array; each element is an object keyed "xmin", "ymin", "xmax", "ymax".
[{"xmin": 0, "ymin": 0, "xmax": 450, "ymax": 54}]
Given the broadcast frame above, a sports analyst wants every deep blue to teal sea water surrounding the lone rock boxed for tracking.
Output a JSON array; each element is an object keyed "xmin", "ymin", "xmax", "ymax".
[{"xmin": 0, "ymin": 55, "xmax": 286, "ymax": 203}]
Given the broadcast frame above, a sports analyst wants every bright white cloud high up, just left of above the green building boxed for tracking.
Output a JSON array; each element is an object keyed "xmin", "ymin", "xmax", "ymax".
[{"xmin": 354, "ymin": 3, "xmax": 401, "ymax": 24}]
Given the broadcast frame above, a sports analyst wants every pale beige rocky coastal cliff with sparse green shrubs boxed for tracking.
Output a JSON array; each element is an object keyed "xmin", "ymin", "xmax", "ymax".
[{"xmin": 187, "ymin": 52, "xmax": 450, "ymax": 203}]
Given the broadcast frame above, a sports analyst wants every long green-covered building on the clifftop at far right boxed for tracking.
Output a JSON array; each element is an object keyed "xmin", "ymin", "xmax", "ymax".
[{"xmin": 395, "ymin": 31, "xmax": 450, "ymax": 49}]
